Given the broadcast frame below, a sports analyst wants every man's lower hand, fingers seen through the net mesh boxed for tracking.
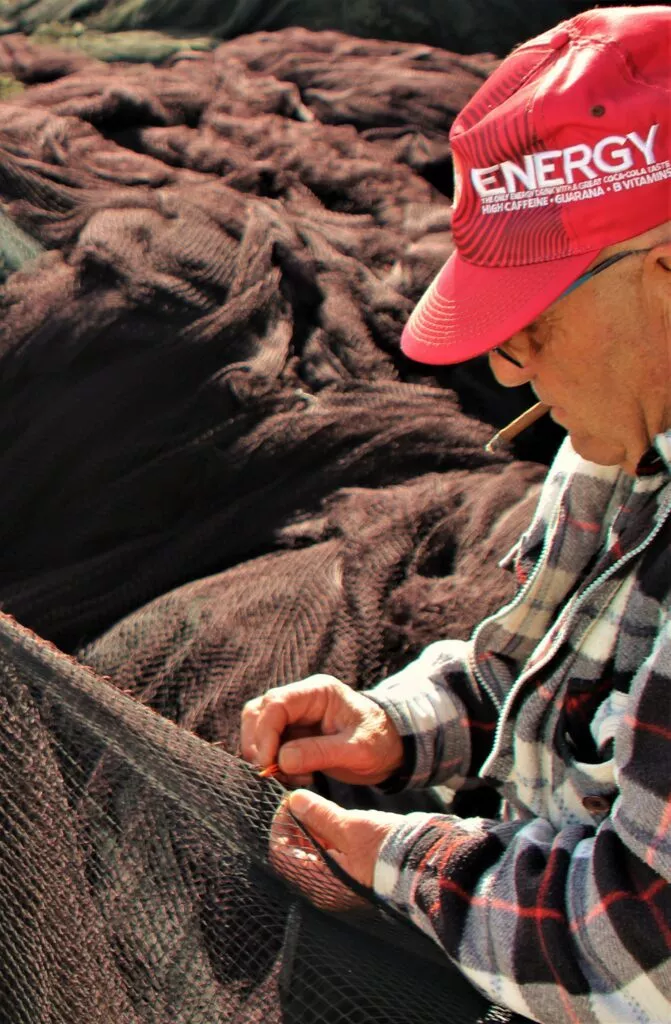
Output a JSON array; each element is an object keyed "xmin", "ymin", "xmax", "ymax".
[{"xmin": 270, "ymin": 790, "xmax": 405, "ymax": 910}]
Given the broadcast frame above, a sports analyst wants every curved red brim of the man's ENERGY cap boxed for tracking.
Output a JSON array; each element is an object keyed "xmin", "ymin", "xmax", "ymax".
[{"xmin": 401, "ymin": 250, "xmax": 597, "ymax": 366}]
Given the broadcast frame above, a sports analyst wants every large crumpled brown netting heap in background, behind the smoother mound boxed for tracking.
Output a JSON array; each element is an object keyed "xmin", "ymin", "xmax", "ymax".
[{"xmin": 0, "ymin": 36, "xmax": 561, "ymax": 650}]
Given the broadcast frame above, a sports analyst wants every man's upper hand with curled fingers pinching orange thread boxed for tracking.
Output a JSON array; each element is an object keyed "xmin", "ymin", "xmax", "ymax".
[{"xmin": 241, "ymin": 676, "xmax": 403, "ymax": 785}]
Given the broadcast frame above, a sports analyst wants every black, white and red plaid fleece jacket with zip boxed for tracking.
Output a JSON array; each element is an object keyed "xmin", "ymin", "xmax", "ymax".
[{"xmin": 369, "ymin": 431, "xmax": 671, "ymax": 1024}]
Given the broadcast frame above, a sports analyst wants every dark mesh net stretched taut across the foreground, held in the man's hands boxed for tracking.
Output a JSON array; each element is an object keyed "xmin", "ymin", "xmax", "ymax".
[{"xmin": 0, "ymin": 617, "xmax": 524, "ymax": 1024}]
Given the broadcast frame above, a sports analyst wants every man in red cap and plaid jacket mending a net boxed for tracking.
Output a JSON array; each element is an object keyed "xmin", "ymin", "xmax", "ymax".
[{"xmin": 242, "ymin": 6, "xmax": 671, "ymax": 1024}]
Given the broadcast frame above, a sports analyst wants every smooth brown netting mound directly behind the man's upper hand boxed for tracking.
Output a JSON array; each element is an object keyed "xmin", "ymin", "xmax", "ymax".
[{"xmin": 80, "ymin": 464, "xmax": 541, "ymax": 752}]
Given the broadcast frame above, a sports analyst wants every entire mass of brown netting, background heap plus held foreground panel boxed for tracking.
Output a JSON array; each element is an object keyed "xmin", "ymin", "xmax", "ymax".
[{"xmin": 0, "ymin": 30, "xmax": 554, "ymax": 1024}]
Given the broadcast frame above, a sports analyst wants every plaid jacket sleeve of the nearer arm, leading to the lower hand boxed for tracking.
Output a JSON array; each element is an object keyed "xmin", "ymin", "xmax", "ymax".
[{"xmin": 374, "ymin": 622, "xmax": 671, "ymax": 1024}]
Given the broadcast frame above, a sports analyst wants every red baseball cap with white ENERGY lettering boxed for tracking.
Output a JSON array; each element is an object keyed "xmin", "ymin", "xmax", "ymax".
[{"xmin": 402, "ymin": 6, "xmax": 671, "ymax": 365}]
